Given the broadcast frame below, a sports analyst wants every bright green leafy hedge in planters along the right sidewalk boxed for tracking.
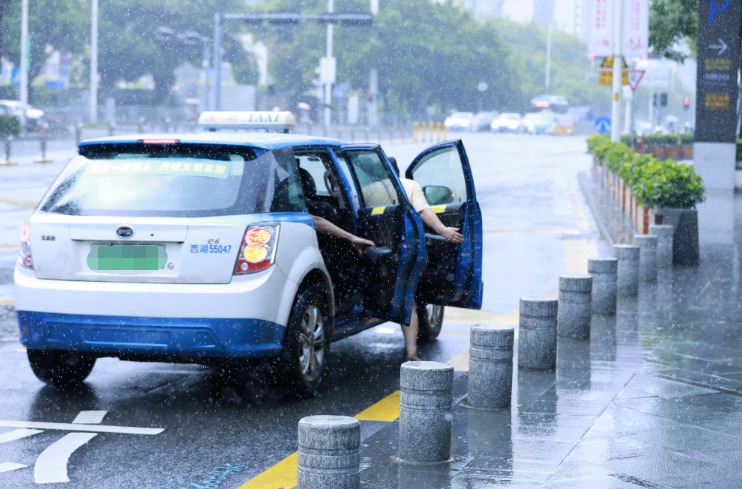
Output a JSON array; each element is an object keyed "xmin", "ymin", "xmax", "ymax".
[{"xmin": 587, "ymin": 134, "xmax": 705, "ymax": 209}]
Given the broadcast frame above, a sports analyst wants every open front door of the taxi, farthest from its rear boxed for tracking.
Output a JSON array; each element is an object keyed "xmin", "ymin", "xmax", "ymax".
[{"xmin": 406, "ymin": 140, "xmax": 482, "ymax": 309}]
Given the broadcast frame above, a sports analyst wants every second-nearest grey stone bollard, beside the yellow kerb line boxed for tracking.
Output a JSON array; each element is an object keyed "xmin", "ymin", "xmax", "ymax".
[{"xmin": 399, "ymin": 362, "xmax": 453, "ymax": 463}]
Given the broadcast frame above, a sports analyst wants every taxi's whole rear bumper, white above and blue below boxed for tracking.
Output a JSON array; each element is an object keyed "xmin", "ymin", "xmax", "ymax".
[{"xmin": 14, "ymin": 266, "xmax": 298, "ymax": 358}]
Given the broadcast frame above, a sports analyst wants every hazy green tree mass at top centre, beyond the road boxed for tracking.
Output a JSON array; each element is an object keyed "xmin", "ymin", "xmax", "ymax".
[{"xmin": 260, "ymin": 0, "xmax": 524, "ymax": 113}]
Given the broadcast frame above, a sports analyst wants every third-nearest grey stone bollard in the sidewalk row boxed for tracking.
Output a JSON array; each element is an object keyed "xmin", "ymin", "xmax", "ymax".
[{"xmin": 468, "ymin": 324, "xmax": 515, "ymax": 409}]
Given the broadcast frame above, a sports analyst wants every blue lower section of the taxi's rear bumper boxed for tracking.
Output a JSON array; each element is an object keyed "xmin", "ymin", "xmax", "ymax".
[{"xmin": 17, "ymin": 311, "xmax": 285, "ymax": 358}]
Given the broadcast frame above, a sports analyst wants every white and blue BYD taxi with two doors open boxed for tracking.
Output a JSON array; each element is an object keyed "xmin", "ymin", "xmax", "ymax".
[{"xmin": 14, "ymin": 112, "xmax": 482, "ymax": 395}]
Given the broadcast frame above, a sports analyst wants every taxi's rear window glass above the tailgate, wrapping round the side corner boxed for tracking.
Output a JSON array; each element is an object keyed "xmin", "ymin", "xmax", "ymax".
[{"xmin": 41, "ymin": 143, "xmax": 306, "ymax": 217}]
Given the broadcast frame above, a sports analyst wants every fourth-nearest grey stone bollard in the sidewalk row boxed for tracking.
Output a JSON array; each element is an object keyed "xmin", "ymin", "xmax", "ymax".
[{"xmin": 518, "ymin": 299, "xmax": 559, "ymax": 370}]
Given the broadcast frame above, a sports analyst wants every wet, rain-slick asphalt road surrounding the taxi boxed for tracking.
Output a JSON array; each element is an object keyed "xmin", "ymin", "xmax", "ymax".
[{"xmin": 0, "ymin": 134, "xmax": 605, "ymax": 488}]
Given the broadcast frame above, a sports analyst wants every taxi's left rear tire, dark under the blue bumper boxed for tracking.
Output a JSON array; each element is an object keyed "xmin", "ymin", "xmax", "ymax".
[{"xmin": 27, "ymin": 349, "xmax": 95, "ymax": 387}]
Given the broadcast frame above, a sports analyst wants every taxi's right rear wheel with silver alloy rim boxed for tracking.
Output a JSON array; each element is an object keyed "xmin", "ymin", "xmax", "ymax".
[{"xmin": 282, "ymin": 285, "xmax": 330, "ymax": 397}]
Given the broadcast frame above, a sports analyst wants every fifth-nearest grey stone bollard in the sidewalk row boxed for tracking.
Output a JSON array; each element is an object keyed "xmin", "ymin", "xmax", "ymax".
[{"xmin": 557, "ymin": 275, "xmax": 593, "ymax": 340}]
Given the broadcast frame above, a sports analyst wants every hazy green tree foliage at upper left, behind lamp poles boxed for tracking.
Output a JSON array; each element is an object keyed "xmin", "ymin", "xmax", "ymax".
[{"xmin": 0, "ymin": 0, "xmax": 254, "ymax": 102}]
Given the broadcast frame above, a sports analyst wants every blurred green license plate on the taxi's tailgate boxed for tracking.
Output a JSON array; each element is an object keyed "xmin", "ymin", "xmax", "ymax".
[{"xmin": 88, "ymin": 245, "xmax": 167, "ymax": 271}]
